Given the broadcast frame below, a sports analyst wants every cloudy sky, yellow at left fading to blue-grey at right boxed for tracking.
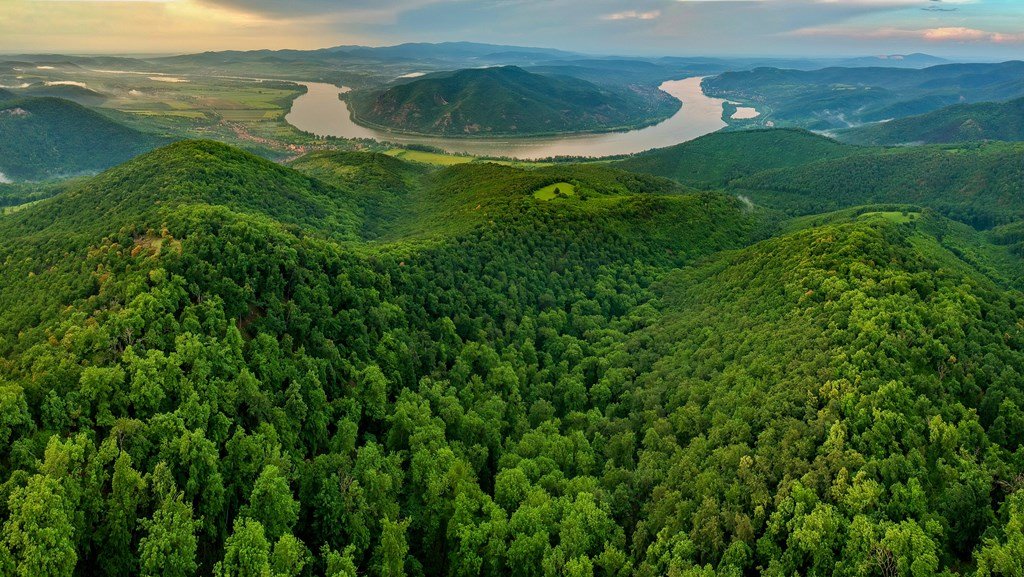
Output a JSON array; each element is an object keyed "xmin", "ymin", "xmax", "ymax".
[{"xmin": 0, "ymin": 0, "xmax": 1024, "ymax": 59}]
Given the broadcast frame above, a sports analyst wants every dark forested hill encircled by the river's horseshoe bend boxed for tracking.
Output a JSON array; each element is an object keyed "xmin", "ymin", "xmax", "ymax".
[{"xmin": 348, "ymin": 67, "xmax": 680, "ymax": 136}]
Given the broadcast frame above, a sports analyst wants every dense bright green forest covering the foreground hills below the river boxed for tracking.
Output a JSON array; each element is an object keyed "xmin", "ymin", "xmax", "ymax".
[{"xmin": 0, "ymin": 130, "xmax": 1024, "ymax": 577}]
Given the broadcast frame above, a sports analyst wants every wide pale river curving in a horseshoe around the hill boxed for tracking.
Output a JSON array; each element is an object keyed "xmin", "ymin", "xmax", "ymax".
[{"xmin": 285, "ymin": 77, "xmax": 726, "ymax": 160}]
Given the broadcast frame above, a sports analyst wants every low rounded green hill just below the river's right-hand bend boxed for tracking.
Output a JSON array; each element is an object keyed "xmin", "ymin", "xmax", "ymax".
[{"xmin": 615, "ymin": 129, "xmax": 865, "ymax": 188}]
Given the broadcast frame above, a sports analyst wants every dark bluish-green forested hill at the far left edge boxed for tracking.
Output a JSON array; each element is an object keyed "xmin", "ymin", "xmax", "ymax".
[{"xmin": 0, "ymin": 98, "xmax": 166, "ymax": 180}]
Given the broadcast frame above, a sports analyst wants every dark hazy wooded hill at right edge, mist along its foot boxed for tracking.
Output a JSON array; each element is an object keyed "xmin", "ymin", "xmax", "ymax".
[{"xmin": 838, "ymin": 98, "xmax": 1024, "ymax": 145}]
